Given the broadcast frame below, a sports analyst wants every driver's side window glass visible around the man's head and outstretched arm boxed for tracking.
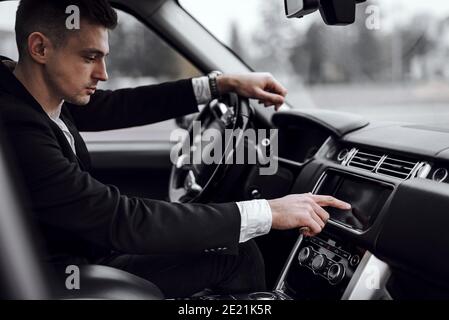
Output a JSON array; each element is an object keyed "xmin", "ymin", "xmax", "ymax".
[{"xmin": 0, "ymin": 1, "xmax": 201, "ymax": 141}]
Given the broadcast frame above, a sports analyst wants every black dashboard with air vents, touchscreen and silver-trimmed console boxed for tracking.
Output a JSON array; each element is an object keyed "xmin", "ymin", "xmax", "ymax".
[{"xmin": 248, "ymin": 110, "xmax": 449, "ymax": 299}]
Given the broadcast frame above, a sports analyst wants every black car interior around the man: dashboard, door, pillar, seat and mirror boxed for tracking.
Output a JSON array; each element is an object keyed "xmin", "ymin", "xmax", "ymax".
[{"xmin": 0, "ymin": 0, "xmax": 449, "ymax": 300}]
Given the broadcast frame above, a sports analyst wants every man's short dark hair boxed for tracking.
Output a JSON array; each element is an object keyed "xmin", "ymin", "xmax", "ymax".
[{"xmin": 16, "ymin": 0, "xmax": 117, "ymax": 56}]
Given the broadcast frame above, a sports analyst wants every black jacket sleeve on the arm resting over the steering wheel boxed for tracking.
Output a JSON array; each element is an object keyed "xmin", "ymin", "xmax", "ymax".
[{"xmin": 66, "ymin": 80, "xmax": 198, "ymax": 131}]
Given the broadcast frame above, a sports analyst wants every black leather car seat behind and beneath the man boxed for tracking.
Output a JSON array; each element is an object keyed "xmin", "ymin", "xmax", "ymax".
[{"xmin": 0, "ymin": 63, "xmax": 164, "ymax": 300}]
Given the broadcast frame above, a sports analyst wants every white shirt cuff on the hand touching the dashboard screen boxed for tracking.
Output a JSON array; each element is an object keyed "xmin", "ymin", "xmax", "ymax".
[{"xmin": 237, "ymin": 199, "xmax": 273, "ymax": 243}]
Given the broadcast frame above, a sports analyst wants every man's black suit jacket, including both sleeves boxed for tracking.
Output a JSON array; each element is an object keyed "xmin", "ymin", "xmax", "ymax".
[{"xmin": 0, "ymin": 63, "xmax": 240, "ymax": 261}]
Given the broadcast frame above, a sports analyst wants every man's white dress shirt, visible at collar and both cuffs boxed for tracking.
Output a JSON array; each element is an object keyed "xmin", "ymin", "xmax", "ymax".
[{"xmin": 49, "ymin": 77, "xmax": 272, "ymax": 242}]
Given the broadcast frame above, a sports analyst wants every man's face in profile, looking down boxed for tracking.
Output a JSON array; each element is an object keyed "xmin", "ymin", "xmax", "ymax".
[{"xmin": 44, "ymin": 21, "xmax": 109, "ymax": 105}]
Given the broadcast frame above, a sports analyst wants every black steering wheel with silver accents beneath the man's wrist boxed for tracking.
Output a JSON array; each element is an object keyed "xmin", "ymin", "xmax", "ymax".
[{"xmin": 168, "ymin": 93, "xmax": 251, "ymax": 203}]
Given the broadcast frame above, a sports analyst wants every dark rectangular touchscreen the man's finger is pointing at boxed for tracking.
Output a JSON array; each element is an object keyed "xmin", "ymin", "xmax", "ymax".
[{"xmin": 318, "ymin": 171, "xmax": 393, "ymax": 231}]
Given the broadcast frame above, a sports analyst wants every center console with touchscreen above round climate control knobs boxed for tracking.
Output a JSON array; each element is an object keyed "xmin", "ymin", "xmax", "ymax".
[{"xmin": 195, "ymin": 168, "xmax": 394, "ymax": 300}]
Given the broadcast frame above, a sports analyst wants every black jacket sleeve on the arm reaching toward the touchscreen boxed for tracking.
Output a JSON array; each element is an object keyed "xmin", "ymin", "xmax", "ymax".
[{"xmin": 0, "ymin": 106, "xmax": 240, "ymax": 254}]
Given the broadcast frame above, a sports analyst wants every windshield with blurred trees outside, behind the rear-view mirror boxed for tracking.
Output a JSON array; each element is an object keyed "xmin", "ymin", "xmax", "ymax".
[{"xmin": 179, "ymin": 0, "xmax": 449, "ymax": 127}]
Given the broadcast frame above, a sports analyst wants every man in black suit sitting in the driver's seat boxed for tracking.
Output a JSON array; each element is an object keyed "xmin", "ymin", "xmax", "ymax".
[{"xmin": 0, "ymin": 0, "xmax": 348, "ymax": 297}]
